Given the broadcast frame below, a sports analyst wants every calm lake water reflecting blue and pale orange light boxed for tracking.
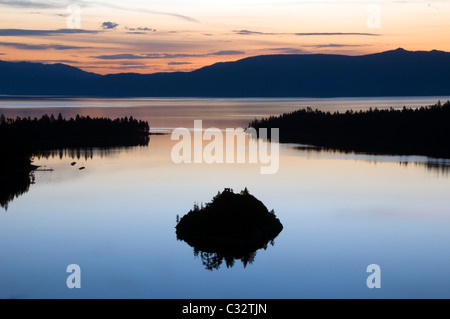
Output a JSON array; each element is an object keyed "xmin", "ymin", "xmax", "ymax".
[{"xmin": 0, "ymin": 97, "xmax": 450, "ymax": 298}]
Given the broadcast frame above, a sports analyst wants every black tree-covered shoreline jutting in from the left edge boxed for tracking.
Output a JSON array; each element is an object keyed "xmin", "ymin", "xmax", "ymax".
[{"xmin": 0, "ymin": 114, "xmax": 149, "ymax": 208}]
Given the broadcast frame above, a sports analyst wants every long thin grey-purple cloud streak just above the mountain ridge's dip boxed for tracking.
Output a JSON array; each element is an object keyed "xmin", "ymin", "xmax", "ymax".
[{"xmin": 92, "ymin": 50, "xmax": 245, "ymax": 60}]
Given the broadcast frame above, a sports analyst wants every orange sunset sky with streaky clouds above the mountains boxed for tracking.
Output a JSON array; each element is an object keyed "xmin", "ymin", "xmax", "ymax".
[{"xmin": 0, "ymin": 0, "xmax": 450, "ymax": 74}]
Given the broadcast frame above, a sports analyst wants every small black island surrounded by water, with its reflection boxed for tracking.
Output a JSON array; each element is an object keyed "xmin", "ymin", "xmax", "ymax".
[{"xmin": 176, "ymin": 188, "xmax": 283, "ymax": 270}]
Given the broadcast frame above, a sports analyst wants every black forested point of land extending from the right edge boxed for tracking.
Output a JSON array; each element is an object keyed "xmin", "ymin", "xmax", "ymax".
[{"xmin": 249, "ymin": 101, "xmax": 450, "ymax": 158}]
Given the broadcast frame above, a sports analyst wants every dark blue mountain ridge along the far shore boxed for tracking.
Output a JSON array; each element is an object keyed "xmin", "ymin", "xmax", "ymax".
[{"xmin": 0, "ymin": 49, "xmax": 450, "ymax": 97}]
